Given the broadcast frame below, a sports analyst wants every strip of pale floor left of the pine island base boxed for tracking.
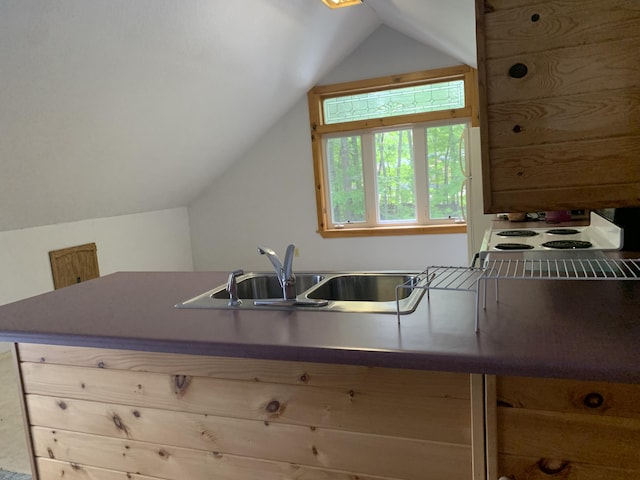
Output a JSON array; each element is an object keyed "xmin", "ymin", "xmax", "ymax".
[{"xmin": 0, "ymin": 352, "xmax": 31, "ymax": 474}]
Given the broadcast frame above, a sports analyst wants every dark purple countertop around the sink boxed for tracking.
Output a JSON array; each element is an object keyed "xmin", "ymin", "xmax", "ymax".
[{"xmin": 0, "ymin": 272, "xmax": 640, "ymax": 383}]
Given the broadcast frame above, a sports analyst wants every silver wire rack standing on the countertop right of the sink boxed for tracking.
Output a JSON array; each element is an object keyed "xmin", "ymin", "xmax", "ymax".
[{"xmin": 396, "ymin": 258, "xmax": 640, "ymax": 332}]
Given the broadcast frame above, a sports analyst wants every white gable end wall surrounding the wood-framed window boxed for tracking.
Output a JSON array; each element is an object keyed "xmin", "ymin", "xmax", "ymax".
[{"xmin": 189, "ymin": 27, "xmax": 467, "ymax": 271}]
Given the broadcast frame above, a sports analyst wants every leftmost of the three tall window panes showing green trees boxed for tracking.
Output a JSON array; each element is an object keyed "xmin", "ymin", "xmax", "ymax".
[{"xmin": 326, "ymin": 135, "xmax": 366, "ymax": 223}]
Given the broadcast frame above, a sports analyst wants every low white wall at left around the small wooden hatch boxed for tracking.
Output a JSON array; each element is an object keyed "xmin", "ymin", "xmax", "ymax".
[{"xmin": 0, "ymin": 208, "xmax": 193, "ymax": 305}]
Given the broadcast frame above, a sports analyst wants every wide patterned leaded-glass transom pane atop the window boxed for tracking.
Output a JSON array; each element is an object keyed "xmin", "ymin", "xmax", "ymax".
[{"xmin": 322, "ymin": 80, "xmax": 464, "ymax": 124}]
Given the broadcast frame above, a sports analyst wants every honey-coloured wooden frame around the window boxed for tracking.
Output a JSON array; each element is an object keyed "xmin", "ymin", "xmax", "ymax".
[{"xmin": 307, "ymin": 65, "xmax": 479, "ymax": 238}]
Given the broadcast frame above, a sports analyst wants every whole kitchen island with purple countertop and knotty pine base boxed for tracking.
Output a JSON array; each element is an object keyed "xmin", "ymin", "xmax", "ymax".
[{"xmin": 0, "ymin": 272, "xmax": 640, "ymax": 480}]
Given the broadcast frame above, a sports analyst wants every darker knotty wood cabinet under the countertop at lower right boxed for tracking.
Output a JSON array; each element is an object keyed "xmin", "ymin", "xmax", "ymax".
[{"xmin": 491, "ymin": 377, "xmax": 640, "ymax": 480}]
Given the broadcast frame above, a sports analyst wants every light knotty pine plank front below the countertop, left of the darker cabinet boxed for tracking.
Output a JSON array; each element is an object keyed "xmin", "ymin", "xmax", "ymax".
[{"xmin": 13, "ymin": 344, "xmax": 485, "ymax": 480}]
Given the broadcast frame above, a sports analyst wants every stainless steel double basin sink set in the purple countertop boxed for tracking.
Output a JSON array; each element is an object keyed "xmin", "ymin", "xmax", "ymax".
[{"xmin": 176, "ymin": 272, "xmax": 427, "ymax": 314}]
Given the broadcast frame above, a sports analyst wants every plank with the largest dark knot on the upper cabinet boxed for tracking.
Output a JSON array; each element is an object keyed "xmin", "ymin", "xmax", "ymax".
[{"xmin": 486, "ymin": 37, "xmax": 640, "ymax": 105}]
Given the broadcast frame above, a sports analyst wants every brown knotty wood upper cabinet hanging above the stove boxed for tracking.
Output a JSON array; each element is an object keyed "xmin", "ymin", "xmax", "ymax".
[{"xmin": 476, "ymin": 0, "xmax": 640, "ymax": 213}]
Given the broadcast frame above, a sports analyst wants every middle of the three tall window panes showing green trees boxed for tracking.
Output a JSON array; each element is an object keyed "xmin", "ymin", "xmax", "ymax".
[{"xmin": 374, "ymin": 130, "xmax": 416, "ymax": 223}]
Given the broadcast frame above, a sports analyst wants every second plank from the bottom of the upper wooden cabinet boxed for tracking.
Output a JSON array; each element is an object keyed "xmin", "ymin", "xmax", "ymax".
[{"xmin": 491, "ymin": 137, "xmax": 640, "ymax": 191}]
